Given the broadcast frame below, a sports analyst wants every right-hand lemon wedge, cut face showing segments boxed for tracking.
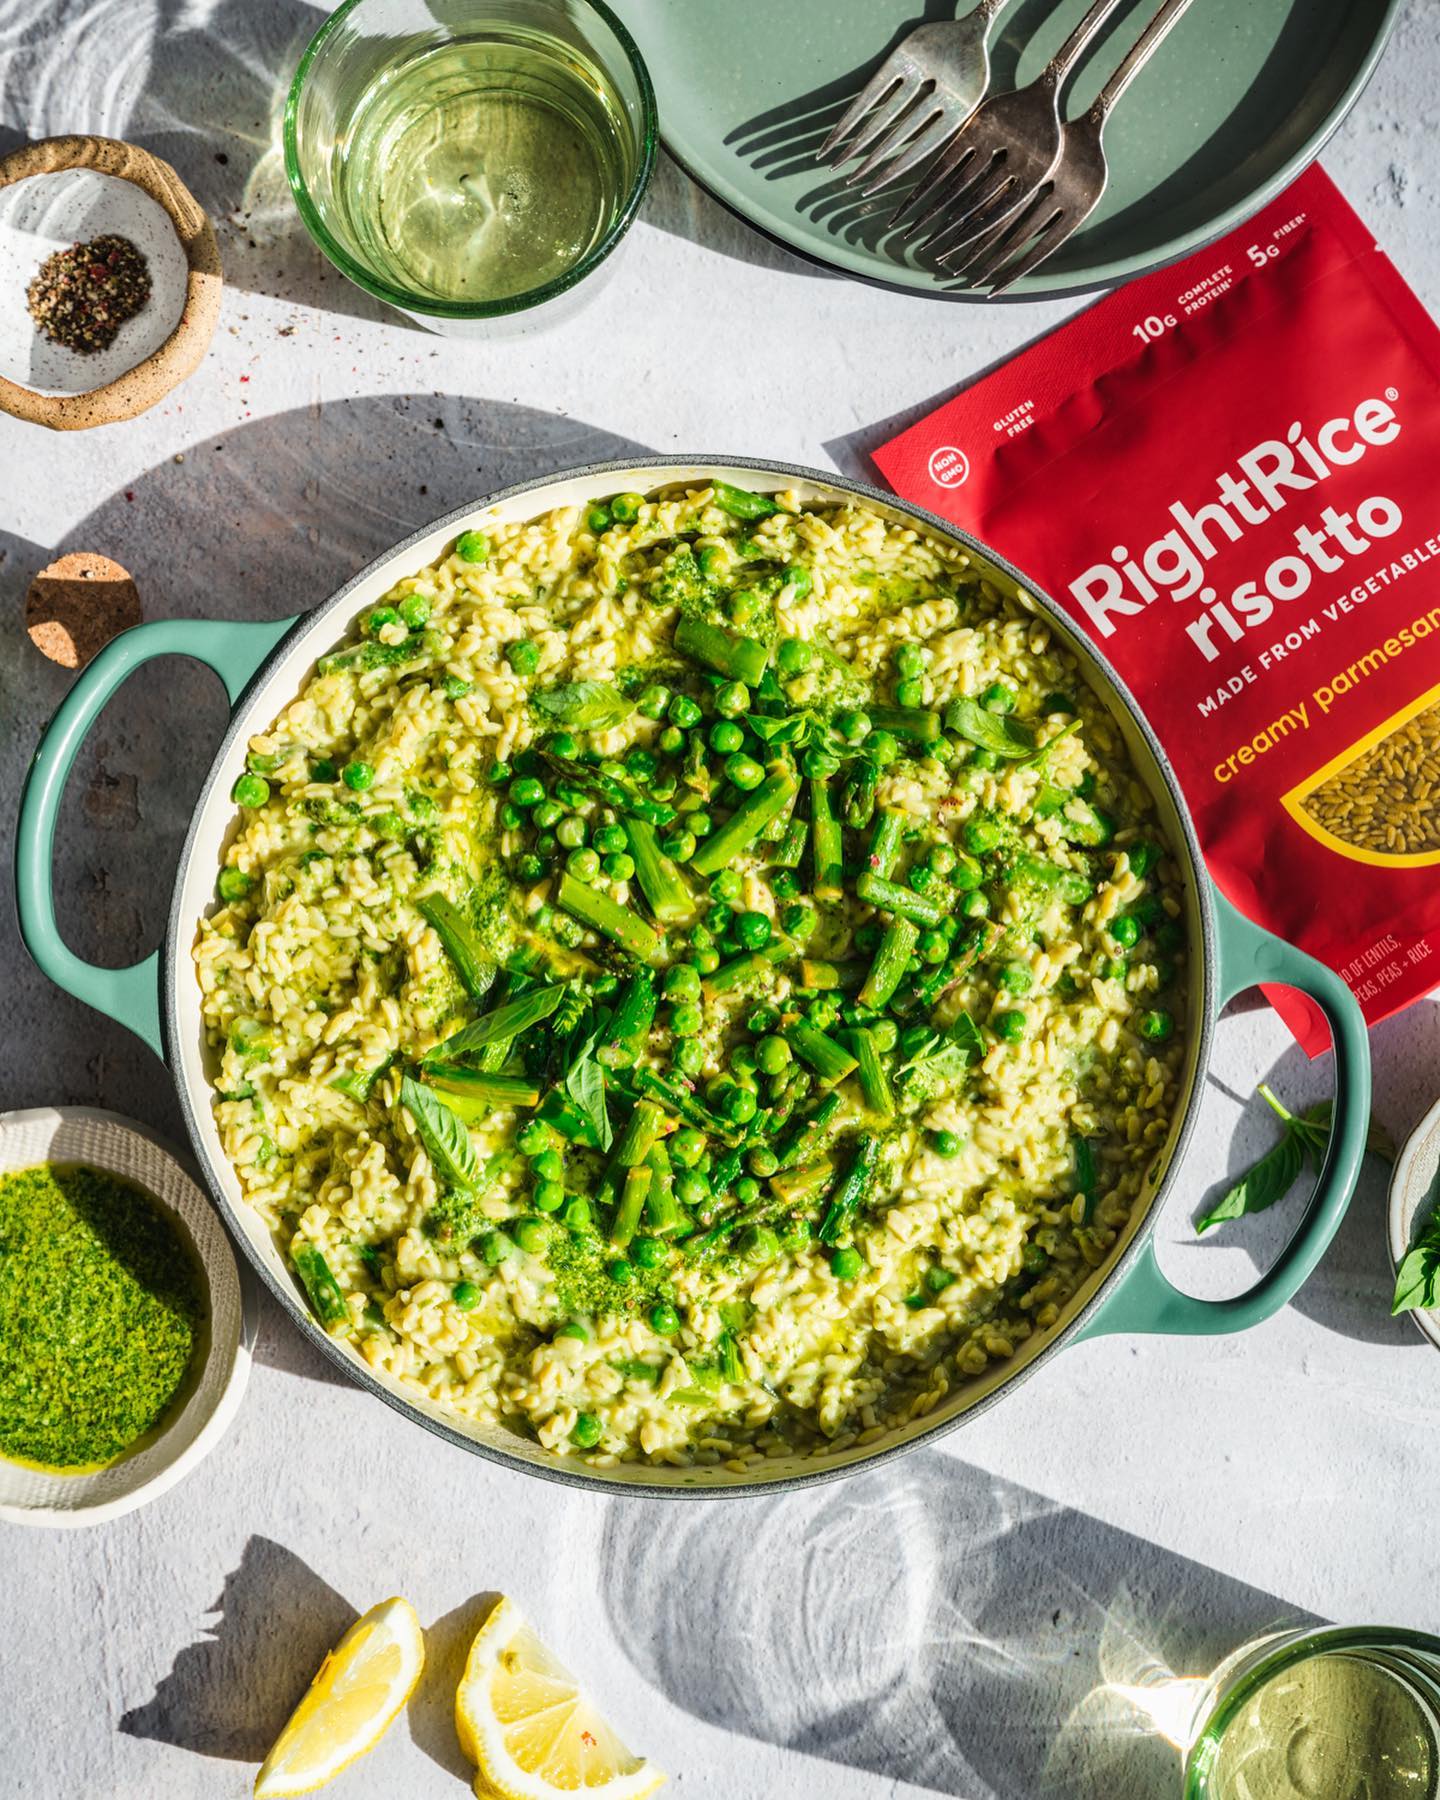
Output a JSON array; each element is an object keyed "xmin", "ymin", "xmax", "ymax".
[{"xmin": 455, "ymin": 1600, "xmax": 664, "ymax": 1800}]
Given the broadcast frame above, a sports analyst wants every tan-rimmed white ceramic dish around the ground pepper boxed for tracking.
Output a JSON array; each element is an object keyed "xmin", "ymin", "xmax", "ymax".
[{"xmin": 0, "ymin": 137, "xmax": 221, "ymax": 432}]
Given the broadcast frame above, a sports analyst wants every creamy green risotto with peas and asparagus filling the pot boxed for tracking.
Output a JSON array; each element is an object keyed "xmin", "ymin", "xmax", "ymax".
[{"xmin": 194, "ymin": 482, "xmax": 1186, "ymax": 1469}]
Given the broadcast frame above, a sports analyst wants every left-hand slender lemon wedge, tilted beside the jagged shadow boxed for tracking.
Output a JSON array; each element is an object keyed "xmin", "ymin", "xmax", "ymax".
[{"xmin": 256, "ymin": 1600, "xmax": 425, "ymax": 1800}]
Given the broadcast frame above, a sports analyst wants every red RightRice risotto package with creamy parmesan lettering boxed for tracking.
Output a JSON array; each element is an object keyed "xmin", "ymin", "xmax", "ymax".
[{"xmin": 877, "ymin": 169, "xmax": 1440, "ymax": 1055}]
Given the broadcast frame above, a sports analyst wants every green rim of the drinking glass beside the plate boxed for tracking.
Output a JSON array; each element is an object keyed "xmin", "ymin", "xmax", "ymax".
[{"xmin": 283, "ymin": 0, "xmax": 661, "ymax": 319}]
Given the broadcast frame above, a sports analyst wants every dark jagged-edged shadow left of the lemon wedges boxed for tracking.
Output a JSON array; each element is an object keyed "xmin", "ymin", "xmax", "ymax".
[{"xmin": 121, "ymin": 1537, "xmax": 358, "ymax": 1762}]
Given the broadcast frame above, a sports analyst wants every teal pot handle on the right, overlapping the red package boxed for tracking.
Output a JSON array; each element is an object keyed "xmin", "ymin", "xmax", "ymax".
[{"xmin": 1076, "ymin": 891, "xmax": 1370, "ymax": 1337}]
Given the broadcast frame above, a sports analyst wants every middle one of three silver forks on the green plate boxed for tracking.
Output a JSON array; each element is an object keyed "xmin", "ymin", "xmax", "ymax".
[{"xmin": 895, "ymin": 0, "xmax": 1121, "ymax": 256}]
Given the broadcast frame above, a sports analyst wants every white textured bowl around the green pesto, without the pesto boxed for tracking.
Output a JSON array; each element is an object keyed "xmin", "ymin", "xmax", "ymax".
[{"xmin": 0, "ymin": 1107, "xmax": 256, "ymax": 1526}]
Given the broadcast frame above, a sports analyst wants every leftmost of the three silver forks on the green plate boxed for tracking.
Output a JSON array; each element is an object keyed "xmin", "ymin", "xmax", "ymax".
[{"xmin": 815, "ymin": 0, "xmax": 1008, "ymax": 194}]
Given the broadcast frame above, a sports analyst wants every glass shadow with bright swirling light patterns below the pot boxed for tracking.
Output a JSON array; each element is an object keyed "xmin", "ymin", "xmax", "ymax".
[{"xmin": 603, "ymin": 1453, "xmax": 1309, "ymax": 1800}]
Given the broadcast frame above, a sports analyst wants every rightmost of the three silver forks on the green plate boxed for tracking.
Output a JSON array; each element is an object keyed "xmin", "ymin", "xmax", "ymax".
[{"xmin": 940, "ymin": 0, "xmax": 1192, "ymax": 293}]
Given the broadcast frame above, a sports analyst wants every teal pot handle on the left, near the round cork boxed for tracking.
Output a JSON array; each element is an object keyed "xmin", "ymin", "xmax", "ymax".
[{"xmin": 14, "ymin": 619, "xmax": 295, "ymax": 1060}]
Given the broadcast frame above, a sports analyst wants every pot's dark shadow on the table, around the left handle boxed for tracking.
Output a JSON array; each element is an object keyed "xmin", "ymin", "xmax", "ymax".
[{"xmin": 0, "ymin": 394, "xmax": 650, "ymax": 1138}]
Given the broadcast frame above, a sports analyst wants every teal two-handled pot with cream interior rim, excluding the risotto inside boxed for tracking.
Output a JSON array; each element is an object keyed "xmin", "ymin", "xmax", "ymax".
[{"xmin": 16, "ymin": 457, "xmax": 1370, "ymax": 1494}]
